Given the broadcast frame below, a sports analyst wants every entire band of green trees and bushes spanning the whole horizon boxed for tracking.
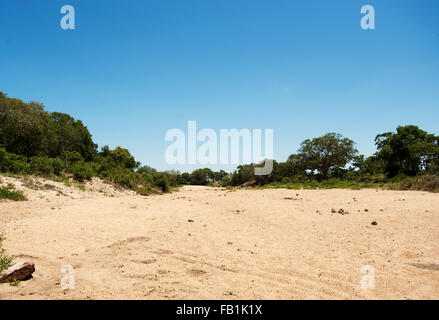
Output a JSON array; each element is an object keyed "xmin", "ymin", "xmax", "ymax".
[{"xmin": 0, "ymin": 92, "xmax": 439, "ymax": 198}]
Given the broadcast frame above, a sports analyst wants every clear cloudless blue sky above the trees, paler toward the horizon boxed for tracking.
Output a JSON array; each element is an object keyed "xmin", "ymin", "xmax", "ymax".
[{"xmin": 0, "ymin": 0, "xmax": 439, "ymax": 170}]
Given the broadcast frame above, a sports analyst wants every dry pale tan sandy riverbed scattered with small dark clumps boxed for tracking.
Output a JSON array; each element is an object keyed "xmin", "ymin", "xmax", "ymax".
[{"xmin": 0, "ymin": 182, "xmax": 439, "ymax": 299}]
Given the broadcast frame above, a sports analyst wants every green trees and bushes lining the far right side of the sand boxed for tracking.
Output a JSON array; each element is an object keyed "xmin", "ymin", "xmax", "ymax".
[{"xmin": 198, "ymin": 125, "xmax": 439, "ymax": 192}]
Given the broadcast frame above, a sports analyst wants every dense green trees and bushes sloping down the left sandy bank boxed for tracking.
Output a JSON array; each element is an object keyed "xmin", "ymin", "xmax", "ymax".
[{"xmin": 0, "ymin": 92, "xmax": 177, "ymax": 199}]
